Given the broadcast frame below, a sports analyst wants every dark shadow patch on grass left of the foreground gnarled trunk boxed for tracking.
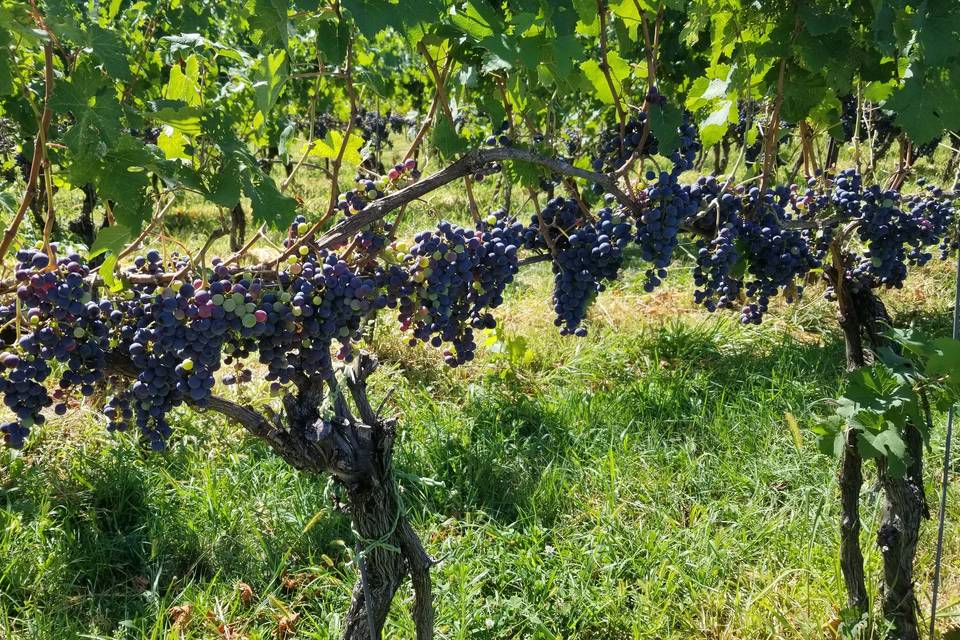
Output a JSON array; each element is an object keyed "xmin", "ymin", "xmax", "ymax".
[{"xmin": 0, "ymin": 440, "xmax": 350, "ymax": 630}]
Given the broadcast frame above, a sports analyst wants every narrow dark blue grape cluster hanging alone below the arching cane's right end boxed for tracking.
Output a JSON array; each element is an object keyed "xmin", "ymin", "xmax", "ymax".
[{"xmin": 553, "ymin": 207, "xmax": 633, "ymax": 337}]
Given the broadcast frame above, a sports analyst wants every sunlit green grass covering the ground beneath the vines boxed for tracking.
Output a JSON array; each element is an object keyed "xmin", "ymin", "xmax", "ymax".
[{"xmin": 0, "ymin": 152, "xmax": 960, "ymax": 640}]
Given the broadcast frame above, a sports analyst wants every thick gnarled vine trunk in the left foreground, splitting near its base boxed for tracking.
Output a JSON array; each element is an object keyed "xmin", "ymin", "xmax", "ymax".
[{"xmin": 107, "ymin": 352, "xmax": 434, "ymax": 640}]
